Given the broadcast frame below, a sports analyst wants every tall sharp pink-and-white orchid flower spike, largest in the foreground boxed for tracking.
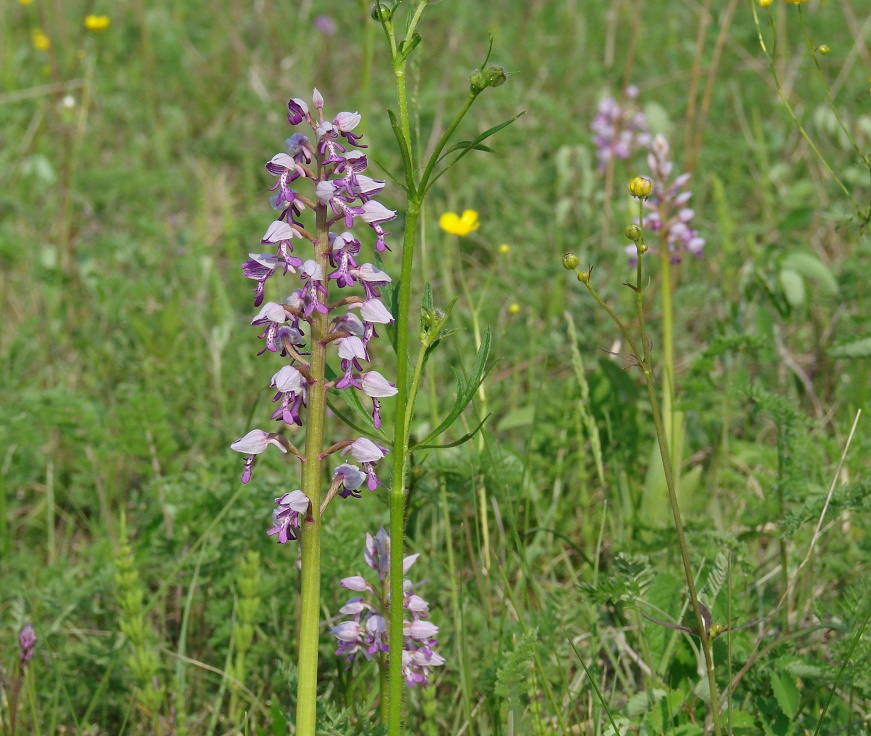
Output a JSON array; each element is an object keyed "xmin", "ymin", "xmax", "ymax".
[{"xmin": 231, "ymin": 90, "xmax": 396, "ymax": 543}]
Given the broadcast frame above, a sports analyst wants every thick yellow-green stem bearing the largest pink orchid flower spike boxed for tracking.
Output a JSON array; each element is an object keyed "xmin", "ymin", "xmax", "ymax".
[{"xmin": 296, "ymin": 183, "xmax": 330, "ymax": 736}]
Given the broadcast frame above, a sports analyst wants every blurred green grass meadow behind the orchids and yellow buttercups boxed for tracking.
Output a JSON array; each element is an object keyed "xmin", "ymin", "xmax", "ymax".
[{"xmin": 0, "ymin": 0, "xmax": 871, "ymax": 736}]
